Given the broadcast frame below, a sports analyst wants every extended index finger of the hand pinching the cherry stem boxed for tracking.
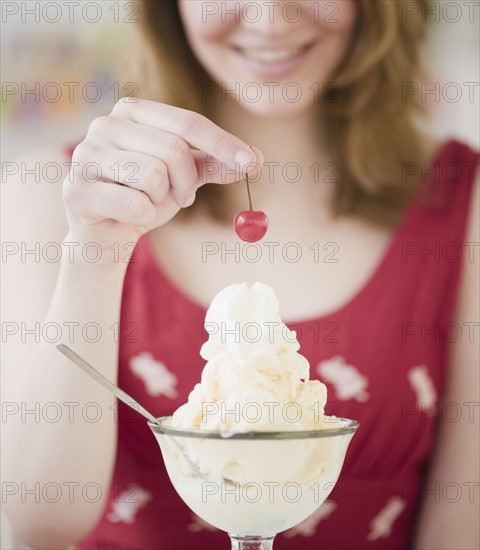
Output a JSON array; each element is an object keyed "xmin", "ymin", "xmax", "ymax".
[{"xmin": 112, "ymin": 98, "xmax": 261, "ymax": 170}]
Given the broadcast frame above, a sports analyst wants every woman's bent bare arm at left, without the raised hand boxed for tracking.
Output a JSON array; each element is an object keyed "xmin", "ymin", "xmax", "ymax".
[{"xmin": 1, "ymin": 146, "xmax": 126, "ymax": 548}]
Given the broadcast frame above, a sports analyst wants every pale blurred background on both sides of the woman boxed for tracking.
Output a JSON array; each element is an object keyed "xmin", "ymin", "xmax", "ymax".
[{"xmin": 0, "ymin": 0, "xmax": 480, "ymax": 549}]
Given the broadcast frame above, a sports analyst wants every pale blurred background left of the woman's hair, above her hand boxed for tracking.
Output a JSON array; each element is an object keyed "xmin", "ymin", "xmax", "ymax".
[{"xmin": 1, "ymin": 0, "xmax": 122, "ymax": 161}]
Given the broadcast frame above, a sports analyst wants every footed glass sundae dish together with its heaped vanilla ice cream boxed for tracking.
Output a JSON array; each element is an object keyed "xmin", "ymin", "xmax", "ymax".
[{"xmin": 149, "ymin": 283, "xmax": 358, "ymax": 550}]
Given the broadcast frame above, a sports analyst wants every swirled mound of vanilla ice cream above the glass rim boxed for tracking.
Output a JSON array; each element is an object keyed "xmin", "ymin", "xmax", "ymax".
[{"xmin": 172, "ymin": 282, "xmax": 329, "ymax": 432}]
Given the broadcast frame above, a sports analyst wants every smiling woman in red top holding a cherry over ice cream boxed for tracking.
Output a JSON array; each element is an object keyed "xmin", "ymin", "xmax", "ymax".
[{"xmin": 4, "ymin": 0, "xmax": 479, "ymax": 550}]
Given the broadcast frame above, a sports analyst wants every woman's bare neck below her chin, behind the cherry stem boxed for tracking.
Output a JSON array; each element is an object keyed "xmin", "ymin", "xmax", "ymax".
[{"xmin": 209, "ymin": 98, "xmax": 333, "ymax": 225}]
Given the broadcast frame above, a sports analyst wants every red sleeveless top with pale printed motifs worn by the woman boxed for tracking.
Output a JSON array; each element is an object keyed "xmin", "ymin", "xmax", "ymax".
[{"xmin": 71, "ymin": 141, "xmax": 478, "ymax": 550}]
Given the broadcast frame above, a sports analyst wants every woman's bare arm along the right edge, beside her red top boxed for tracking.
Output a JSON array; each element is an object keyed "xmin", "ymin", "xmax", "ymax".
[{"xmin": 414, "ymin": 174, "xmax": 480, "ymax": 550}]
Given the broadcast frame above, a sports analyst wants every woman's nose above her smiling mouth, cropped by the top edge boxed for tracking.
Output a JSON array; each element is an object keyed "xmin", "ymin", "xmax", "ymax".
[{"xmin": 239, "ymin": 0, "xmax": 303, "ymax": 38}]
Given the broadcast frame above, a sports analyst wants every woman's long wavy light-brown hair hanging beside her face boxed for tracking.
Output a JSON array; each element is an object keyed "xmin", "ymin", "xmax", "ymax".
[{"xmin": 126, "ymin": 0, "xmax": 428, "ymax": 225}]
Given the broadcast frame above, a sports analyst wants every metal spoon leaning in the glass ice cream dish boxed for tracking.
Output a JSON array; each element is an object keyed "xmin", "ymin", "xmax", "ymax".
[{"xmin": 57, "ymin": 344, "xmax": 208, "ymax": 480}]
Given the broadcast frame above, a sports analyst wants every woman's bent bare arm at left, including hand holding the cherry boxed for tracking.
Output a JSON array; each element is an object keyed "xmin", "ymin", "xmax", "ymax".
[{"xmin": 2, "ymin": 98, "xmax": 262, "ymax": 549}]
